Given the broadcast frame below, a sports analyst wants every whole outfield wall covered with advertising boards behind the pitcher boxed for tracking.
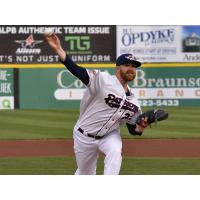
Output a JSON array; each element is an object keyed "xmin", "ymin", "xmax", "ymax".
[{"xmin": 0, "ymin": 25, "xmax": 200, "ymax": 109}]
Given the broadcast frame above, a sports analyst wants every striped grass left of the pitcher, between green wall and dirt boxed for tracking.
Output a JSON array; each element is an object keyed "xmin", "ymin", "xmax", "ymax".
[{"xmin": 0, "ymin": 109, "xmax": 78, "ymax": 139}]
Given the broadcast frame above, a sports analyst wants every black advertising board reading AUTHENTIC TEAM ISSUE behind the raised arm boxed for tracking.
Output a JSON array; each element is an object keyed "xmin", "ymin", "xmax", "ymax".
[{"xmin": 0, "ymin": 25, "xmax": 116, "ymax": 64}]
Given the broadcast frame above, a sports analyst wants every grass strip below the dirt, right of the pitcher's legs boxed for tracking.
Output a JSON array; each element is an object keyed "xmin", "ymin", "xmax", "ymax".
[{"xmin": 121, "ymin": 157, "xmax": 200, "ymax": 175}]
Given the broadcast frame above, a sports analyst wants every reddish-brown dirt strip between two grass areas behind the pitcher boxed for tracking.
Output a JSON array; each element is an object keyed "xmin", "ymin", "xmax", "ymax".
[{"xmin": 0, "ymin": 139, "xmax": 200, "ymax": 157}]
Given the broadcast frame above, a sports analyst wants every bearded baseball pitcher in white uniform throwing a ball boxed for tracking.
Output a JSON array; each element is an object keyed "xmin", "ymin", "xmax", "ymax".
[{"xmin": 45, "ymin": 33, "xmax": 167, "ymax": 175}]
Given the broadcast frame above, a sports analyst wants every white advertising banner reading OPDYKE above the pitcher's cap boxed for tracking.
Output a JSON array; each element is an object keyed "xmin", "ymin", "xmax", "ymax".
[{"xmin": 117, "ymin": 26, "xmax": 200, "ymax": 63}]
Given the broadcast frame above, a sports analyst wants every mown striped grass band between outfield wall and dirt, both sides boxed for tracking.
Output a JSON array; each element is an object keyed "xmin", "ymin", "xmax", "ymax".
[{"xmin": 0, "ymin": 107, "xmax": 200, "ymax": 139}]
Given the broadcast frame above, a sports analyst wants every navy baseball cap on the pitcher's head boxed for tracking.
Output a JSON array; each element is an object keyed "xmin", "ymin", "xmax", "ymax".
[{"xmin": 116, "ymin": 53, "xmax": 141, "ymax": 67}]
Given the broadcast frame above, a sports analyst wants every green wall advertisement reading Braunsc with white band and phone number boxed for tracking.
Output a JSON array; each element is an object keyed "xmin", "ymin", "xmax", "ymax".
[{"xmin": 19, "ymin": 66, "xmax": 200, "ymax": 108}]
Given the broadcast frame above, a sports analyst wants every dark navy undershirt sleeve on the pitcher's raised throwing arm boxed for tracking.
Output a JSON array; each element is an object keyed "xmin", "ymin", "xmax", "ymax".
[{"xmin": 61, "ymin": 55, "xmax": 90, "ymax": 85}]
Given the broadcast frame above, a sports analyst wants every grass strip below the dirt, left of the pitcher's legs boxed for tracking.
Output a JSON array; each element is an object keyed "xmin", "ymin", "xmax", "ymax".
[{"xmin": 0, "ymin": 157, "xmax": 76, "ymax": 175}]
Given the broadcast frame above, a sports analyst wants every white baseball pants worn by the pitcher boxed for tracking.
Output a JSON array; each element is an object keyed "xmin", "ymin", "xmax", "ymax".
[{"xmin": 74, "ymin": 129, "xmax": 122, "ymax": 175}]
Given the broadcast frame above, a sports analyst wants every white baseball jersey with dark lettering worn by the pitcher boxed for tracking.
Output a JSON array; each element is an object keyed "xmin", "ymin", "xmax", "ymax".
[{"xmin": 75, "ymin": 70, "xmax": 141, "ymax": 136}]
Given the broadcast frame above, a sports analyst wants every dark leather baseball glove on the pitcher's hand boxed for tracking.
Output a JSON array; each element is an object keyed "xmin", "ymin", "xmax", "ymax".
[{"xmin": 136, "ymin": 109, "xmax": 168, "ymax": 128}]
